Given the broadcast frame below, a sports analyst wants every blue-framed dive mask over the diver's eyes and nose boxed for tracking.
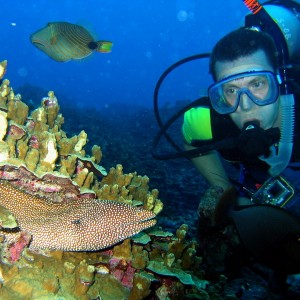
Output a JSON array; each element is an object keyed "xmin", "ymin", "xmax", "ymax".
[{"xmin": 208, "ymin": 71, "xmax": 279, "ymax": 114}]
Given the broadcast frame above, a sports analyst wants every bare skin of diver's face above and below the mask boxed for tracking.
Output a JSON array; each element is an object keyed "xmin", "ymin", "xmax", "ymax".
[{"xmin": 216, "ymin": 50, "xmax": 279, "ymax": 129}]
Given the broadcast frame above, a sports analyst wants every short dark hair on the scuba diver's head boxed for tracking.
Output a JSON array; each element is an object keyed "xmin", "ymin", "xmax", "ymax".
[{"xmin": 209, "ymin": 27, "xmax": 278, "ymax": 80}]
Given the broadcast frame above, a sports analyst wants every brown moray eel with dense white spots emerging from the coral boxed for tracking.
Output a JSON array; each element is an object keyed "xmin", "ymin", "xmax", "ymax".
[{"xmin": 0, "ymin": 182, "xmax": 156, "ymax": 251}]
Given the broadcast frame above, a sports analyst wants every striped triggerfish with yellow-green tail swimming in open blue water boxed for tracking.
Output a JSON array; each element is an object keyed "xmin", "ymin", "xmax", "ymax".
[{"xmin": 30, "ymin": 22, "xmax": 112, "ymax": 62}]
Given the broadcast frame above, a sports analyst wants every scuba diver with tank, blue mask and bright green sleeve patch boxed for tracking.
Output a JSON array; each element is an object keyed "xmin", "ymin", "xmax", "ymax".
[{"xmin": 153, "ymin": 0, "xmax": 300, "ymax": 292}]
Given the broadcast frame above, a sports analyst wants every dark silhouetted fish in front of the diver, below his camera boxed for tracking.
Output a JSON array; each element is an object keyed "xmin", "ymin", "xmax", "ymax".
[{"xmin": 215, "ymin": 188, "xmax": 300, "ymax": 274}]
